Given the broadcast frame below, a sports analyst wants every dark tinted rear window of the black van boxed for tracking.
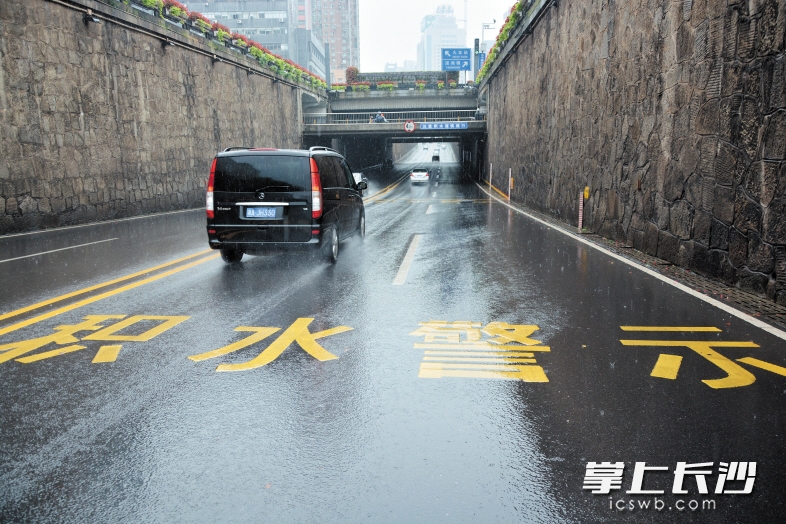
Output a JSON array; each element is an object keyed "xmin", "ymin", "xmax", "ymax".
[{"xmin": 215, "ymin": 155, "xmax": 311, "ymax": 193}]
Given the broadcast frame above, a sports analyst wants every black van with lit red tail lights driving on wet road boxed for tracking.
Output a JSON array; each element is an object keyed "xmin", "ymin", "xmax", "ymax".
[{"xmin": 206, "ymin": 147, "xmax": 368, "ymax": 263}]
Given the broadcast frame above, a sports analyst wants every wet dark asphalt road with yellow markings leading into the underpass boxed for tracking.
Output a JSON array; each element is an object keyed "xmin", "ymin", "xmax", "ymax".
[{"xmin": 0, "ymin": 149, "xmax": 786, "ymax": 523}]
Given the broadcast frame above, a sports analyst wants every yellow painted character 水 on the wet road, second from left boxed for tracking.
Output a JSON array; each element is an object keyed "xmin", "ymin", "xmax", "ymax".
[{"xmin": 188, "ymin": 318, "xmax": 352, "ymax": 371}]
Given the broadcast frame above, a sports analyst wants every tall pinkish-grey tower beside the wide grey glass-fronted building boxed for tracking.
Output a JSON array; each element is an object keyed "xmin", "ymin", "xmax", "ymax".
[{"xmin": 310, "ymin": 0, "xmax": 360, "ymax": 80}]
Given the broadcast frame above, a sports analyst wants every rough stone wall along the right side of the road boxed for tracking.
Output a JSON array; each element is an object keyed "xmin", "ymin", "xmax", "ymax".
[{"xmin": 485, "ymin": 0, "xmax": 786, "ymax": 304}]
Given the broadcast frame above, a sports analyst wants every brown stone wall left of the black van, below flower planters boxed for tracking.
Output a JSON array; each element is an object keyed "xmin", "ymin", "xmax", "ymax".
[{"xmin": 0, "ymin": 0, "xmax": 300, "ymax": 234}]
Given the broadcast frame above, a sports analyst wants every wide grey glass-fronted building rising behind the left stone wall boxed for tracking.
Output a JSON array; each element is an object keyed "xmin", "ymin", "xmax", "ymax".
[{"xmin": 184, "ymin": 0, "xmax": 326, "ymax": 77}]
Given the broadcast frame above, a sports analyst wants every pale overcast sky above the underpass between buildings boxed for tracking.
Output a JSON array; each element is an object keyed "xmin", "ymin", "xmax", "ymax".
[{"xmin": 360, "ymin": 0, "xmax": 517, "ymax": 72}]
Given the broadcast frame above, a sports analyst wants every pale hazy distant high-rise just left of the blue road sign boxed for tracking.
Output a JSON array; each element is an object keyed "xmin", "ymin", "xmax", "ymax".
[{"xmin": 418, "ymin": 4, "xmax": 467, "ymax": 71}]
